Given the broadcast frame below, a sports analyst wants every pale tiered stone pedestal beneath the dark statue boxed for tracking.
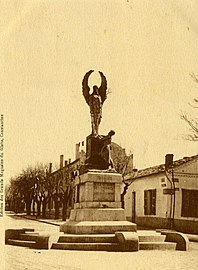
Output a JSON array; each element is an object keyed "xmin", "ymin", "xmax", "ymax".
[{"xmin": 60, "ymin": 170, "xmax": 136, "ymax": 234}]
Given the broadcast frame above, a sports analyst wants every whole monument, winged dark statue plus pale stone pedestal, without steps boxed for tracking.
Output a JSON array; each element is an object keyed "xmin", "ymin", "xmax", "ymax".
[{"xmin": 60, "ymin": 70, "xmax": 136, "ymax": 235}]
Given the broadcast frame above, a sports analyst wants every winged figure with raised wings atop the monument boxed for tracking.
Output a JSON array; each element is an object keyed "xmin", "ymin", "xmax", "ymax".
[{"xmin": 82, "ymin": 70, "xmax": 107, "ymax": 137}]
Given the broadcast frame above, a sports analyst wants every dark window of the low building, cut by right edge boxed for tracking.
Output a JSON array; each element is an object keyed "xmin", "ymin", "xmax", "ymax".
[{"xmin": 181, "ymin": 189, "xmax": 198, "ymax": 217}]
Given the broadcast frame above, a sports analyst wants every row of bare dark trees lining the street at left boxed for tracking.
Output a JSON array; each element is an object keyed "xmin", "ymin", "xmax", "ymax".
[{"xmin": 6, "ymin": 164, "xmax": 71, "ymax": 218}]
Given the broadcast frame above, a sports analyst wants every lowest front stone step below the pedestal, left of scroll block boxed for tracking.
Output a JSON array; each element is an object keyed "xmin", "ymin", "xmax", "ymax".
[{"xmin": 51, "ymin": 243, "xmax": 120, "ymax": 251}]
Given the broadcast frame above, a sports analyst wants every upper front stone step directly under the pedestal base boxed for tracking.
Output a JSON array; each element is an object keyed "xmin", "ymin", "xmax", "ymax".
[{"xmin": 58, "ymin": 234, "xmax": 116, "ymax": 243}]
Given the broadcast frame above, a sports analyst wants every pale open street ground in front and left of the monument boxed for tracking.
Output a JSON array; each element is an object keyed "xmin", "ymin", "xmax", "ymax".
[{"xmin": 1, "ymin": 216, "xmax": 198, "ymax": 270}]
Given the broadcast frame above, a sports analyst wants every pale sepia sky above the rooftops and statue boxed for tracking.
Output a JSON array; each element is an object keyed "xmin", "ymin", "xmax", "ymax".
[{"xmin": 0, "ymin": 0, "xmax": 198, "ymax": 184}]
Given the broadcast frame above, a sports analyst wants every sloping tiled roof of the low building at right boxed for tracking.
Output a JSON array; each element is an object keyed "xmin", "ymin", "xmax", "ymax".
[{"xmin": 125, "ymin": 155, "xmax": 198, "ymax": 180}]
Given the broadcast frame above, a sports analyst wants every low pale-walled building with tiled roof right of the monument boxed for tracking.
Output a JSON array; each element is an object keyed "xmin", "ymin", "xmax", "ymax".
[{"xmin": 125, "ymin": 155, "xmax": 198, "ymax": 233}]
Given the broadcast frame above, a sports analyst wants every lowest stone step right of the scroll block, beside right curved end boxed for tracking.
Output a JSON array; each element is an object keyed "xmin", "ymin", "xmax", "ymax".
[{"xmin": 139, "ymin": 242, "xmax": 176, "ymax": 250}]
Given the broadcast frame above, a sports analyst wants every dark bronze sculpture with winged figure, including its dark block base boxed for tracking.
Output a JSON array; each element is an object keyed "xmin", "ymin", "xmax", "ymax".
[{"xmin": 80, "ymin": 70, "xmax": 115, "ymax": 171}]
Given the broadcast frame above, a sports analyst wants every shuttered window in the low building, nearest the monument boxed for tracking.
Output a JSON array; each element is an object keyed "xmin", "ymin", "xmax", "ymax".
[{"xmin": 144, "ymin": 189, "xmax": 156, "ymax": 215}]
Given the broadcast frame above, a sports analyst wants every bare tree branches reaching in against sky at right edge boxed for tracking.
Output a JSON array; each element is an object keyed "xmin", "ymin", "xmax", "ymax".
[{"xmin": 180, "ymin": 73, "xmax": 198, "ymax": 141}]
